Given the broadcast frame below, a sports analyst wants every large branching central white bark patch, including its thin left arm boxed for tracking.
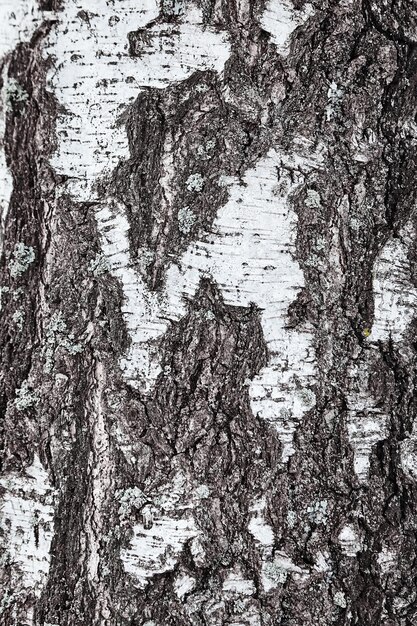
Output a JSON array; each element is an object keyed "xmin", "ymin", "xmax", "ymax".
[{"xmin": 97, "ymin": 145, "xmax": 321, "ymax": 462}]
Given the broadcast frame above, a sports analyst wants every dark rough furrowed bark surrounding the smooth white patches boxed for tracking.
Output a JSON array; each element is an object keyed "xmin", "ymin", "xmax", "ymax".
[{"xmin": 0, "ymin": 0, "xmax": 417, "ymax": 626}]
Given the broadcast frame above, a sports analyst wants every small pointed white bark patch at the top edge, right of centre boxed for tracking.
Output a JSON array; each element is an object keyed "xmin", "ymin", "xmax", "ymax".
[{"xmin": 260, "ymin": 0, "xmax": 314, "ymax": 57}]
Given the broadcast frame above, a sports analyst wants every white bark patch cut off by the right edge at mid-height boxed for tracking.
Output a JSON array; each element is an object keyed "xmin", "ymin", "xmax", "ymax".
[{"xmin": 370, "ymin": 224, "xmax": 417, "ymax": 343}]
